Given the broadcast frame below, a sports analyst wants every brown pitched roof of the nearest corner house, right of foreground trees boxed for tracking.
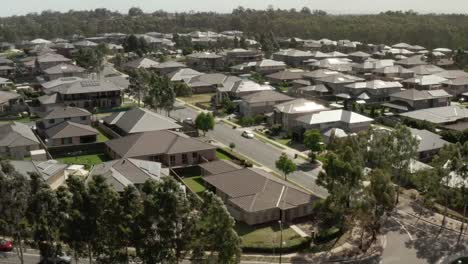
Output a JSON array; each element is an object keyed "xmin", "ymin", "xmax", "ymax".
[{"xmin": 203, "ymin": 168, "xmax": 318, "ymax": 212}]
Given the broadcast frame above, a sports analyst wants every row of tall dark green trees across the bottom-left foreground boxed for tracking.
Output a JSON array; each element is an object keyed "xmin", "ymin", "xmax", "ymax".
[{"xmin": 0, "ymin": 160, "xmax": 241, "ymax": 264}]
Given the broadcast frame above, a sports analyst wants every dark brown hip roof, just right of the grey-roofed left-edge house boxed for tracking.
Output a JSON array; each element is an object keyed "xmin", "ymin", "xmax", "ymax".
[{"xmin": 45, "ymin": 121, "xmax": 99, "ymax": 139}]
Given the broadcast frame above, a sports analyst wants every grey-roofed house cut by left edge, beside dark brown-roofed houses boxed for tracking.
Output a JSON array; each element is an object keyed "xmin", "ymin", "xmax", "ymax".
[{"xmin": 0, "ymin": 122, "xmax": 40, "ymax": 159}]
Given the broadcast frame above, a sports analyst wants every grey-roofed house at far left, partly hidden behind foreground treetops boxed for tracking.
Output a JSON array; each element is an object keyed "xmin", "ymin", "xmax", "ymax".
[{"xmin": 10, "ymin": 160, "xmax": 68, "ymax": 190}]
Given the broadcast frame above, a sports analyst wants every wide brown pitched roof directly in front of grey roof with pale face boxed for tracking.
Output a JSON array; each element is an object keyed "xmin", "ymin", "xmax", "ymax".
[{"xmin": 106, "ymin": 130, "xmax": 216, "ymax": 158}]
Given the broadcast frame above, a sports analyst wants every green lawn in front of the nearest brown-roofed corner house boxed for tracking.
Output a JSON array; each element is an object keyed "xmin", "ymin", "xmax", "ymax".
[{"xmin": 236, "ymin": 222, "xmax": 305, "ymax": 248}]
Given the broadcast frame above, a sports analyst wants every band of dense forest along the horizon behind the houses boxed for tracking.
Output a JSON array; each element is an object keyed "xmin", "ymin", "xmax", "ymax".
[{"xmin": 0, "ymin": 7, "xmax": 468, "ymax": 48}]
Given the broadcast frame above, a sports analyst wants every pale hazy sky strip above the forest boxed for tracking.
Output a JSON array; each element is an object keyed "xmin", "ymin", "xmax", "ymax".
[{"xmin": 0, "ymin": 0, "xmax": 468, "ymax": 16}]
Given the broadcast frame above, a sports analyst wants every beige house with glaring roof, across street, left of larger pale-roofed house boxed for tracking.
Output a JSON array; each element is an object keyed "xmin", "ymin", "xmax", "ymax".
[{"xmin": 271, "ymin": 98, "xmax": 328, "ymax": 130}]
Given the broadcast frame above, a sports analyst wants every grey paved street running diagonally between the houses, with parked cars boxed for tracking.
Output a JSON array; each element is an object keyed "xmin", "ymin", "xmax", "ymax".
[{"xmin": 171, "ymin": 105, "xmax": 327, "ymax": 197}]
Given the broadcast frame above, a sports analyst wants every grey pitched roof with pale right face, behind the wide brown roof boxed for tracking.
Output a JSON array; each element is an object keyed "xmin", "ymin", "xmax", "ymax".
[{"xmin": 103, "ymin": 108, "xmax": 181, "ymax": 134}]
